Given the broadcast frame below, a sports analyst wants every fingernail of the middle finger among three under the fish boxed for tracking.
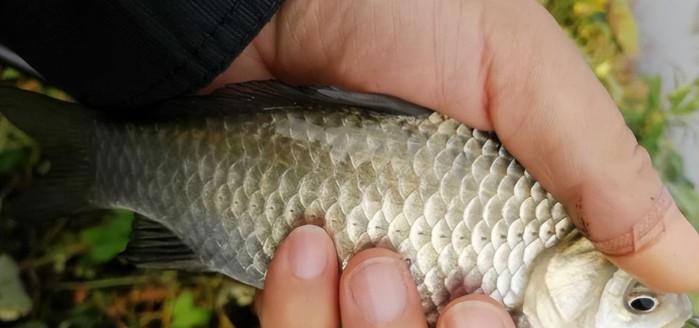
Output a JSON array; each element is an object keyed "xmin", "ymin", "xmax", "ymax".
[{"xmin": 349, "ymin": 257, "xmax": 407, "ymax": 323}]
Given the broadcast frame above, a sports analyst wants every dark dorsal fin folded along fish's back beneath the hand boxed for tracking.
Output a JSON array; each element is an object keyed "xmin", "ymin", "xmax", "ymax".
[{"xmin": 212, "ymin": 80, "xmax": 432, "ymax": 116}]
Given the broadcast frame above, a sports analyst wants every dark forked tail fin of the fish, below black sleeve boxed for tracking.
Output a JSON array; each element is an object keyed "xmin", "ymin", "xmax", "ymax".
[{"xmin": 0, "ymin": 87, "xmax": 97, "ymax": 220}]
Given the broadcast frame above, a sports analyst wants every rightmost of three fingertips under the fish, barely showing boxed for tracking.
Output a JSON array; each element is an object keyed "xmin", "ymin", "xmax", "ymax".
[{"xmin": 437, "ymin": 294, "xmax": 515, "ymax": 328}]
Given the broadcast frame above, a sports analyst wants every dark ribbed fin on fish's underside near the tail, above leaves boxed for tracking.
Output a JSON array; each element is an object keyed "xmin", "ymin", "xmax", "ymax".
[{"xmin": 121, "ymin": 214, "xmax": 208, "ymax": 271}]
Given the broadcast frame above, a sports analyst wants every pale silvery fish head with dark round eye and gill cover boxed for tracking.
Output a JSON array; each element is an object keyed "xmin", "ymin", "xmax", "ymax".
[{"xmin": 522, "ymin": 236, "xmax": 692, "ymax": 328}]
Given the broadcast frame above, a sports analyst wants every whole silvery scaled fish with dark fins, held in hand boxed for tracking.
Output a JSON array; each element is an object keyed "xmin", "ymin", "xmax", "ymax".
[{"xmin": 0, "ymin": 81, "xmax": 692, "ymax": 328}]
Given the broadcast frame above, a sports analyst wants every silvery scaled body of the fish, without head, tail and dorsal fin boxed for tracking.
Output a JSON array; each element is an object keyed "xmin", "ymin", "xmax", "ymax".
[{"xmin": 89, "ymin": 109, "xmax": 573, "ymax": 320}]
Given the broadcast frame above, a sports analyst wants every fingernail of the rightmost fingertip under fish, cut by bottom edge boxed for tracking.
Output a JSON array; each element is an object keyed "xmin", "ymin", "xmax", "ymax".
[{"xmin": 440, "ymin": 301, "xmax": 505, "ymax": 328}]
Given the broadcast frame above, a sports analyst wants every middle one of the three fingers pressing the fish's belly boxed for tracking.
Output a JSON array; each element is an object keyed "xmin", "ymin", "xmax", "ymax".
[{"xmin": 340, "ymin": 248, "xmax": 427, "ymax": 328}]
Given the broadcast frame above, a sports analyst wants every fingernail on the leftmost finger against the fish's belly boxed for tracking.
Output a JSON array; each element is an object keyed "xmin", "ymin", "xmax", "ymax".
[{"xmin": 288, "ymin": 225, "xmax": 328, "ymax": 280}]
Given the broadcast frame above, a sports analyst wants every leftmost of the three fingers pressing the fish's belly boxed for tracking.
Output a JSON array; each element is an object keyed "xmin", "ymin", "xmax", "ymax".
[{"xmin": 256, "ymin": 225, "xmax": 340, "ymax": 328}]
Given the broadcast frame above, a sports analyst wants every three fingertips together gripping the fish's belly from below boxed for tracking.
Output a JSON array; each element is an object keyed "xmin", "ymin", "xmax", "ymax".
[{"xmin": 256, "ymin": 225, "xmax": 514, "ymax": 328}]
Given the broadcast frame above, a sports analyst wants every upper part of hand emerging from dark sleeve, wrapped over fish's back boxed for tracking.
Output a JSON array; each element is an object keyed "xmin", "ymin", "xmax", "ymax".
[{"xmin": 203, "ymin": 0, "xmax": 699, "ymax": 291}]
